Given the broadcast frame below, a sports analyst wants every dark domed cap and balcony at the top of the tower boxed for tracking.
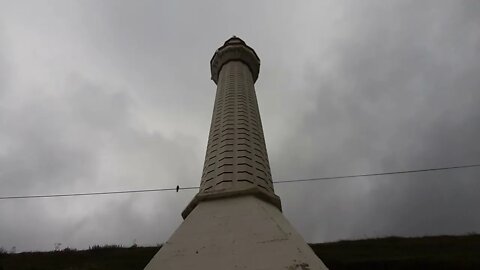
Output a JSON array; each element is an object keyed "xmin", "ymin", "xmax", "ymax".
[{"xmin": 210, "ymin": 36, "xmax": 260, "ymax": 83}]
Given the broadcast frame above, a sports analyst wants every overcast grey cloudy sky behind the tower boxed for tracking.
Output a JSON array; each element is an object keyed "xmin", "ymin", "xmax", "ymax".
[{"xmin": 0, "ymin": 0, "xmax": 480, "ymax": 251}]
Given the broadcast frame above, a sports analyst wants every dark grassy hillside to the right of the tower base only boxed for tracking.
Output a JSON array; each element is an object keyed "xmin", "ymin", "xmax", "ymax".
[{"xmin": 310, "ymin": 234, "xmax": 480, "ymax": 270}]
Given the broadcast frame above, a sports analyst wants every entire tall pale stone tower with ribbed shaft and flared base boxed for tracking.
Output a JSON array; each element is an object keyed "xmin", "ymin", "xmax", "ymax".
[{"xmin": 145, "ymin": 36, "xmax": 327, "ymax": 270}]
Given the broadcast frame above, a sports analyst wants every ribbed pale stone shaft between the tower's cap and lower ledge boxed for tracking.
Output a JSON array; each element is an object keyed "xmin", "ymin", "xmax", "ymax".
[{"xmin": 200, "ymin": 61, "xmax": 273, "ymax": 193}]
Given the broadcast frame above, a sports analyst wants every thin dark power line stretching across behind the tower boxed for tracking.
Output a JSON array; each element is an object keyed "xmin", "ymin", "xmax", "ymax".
[{"xmin": 0, "ymin": 164, "xmax": 480, "ymax": 200}]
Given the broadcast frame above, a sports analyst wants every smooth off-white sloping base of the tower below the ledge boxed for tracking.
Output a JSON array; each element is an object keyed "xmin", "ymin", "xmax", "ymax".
[{"xmin": 145, "ymin": 196, "xmax": 327, "ymax": 270}]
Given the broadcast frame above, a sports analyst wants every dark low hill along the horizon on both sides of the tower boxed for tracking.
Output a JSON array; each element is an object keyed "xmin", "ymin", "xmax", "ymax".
[{"xmin": 0, "ymin": 234, "xmax": 480, "ymax": 270}]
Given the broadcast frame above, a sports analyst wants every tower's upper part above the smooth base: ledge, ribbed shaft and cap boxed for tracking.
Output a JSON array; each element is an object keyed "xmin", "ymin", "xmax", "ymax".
[{"xmin": 182, "ymin": 37, "xmax": 281, "ymax": 217}]
